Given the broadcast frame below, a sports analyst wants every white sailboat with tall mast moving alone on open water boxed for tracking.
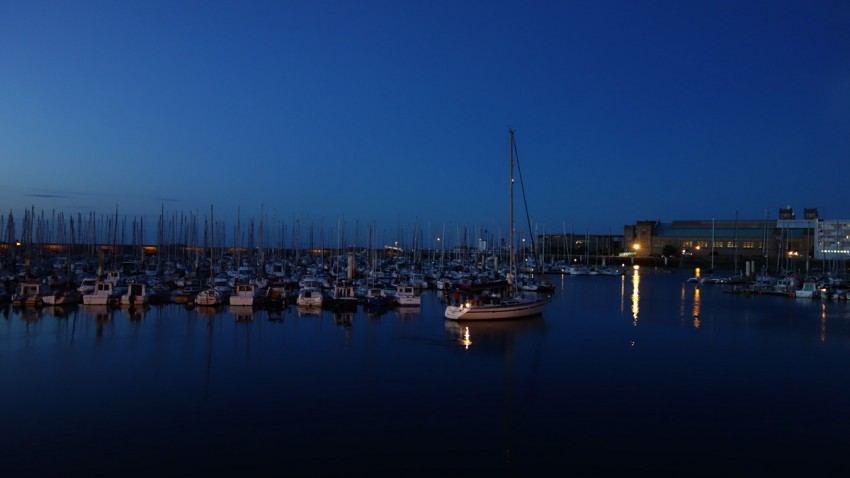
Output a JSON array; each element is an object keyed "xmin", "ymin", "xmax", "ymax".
[{"xmin": 445, "ymin": 130, "xmax": 550, "ymax": 320}]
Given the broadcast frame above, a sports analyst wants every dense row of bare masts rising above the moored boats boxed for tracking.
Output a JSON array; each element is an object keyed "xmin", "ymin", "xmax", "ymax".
[{"xmin": 0, "ymin": 206, "xmax": 604, "ymax": 272}]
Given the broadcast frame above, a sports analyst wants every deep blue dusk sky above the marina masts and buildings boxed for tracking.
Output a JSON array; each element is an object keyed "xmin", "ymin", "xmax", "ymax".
[{"xmin": 0, "ymin": 0, "xmax": 850, "ymax": 245}]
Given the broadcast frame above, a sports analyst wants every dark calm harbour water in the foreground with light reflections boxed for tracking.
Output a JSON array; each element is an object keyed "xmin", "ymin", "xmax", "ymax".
[{"xmin": 0, "ymin": 273, "xmax": 850, "ymax": 477}]
